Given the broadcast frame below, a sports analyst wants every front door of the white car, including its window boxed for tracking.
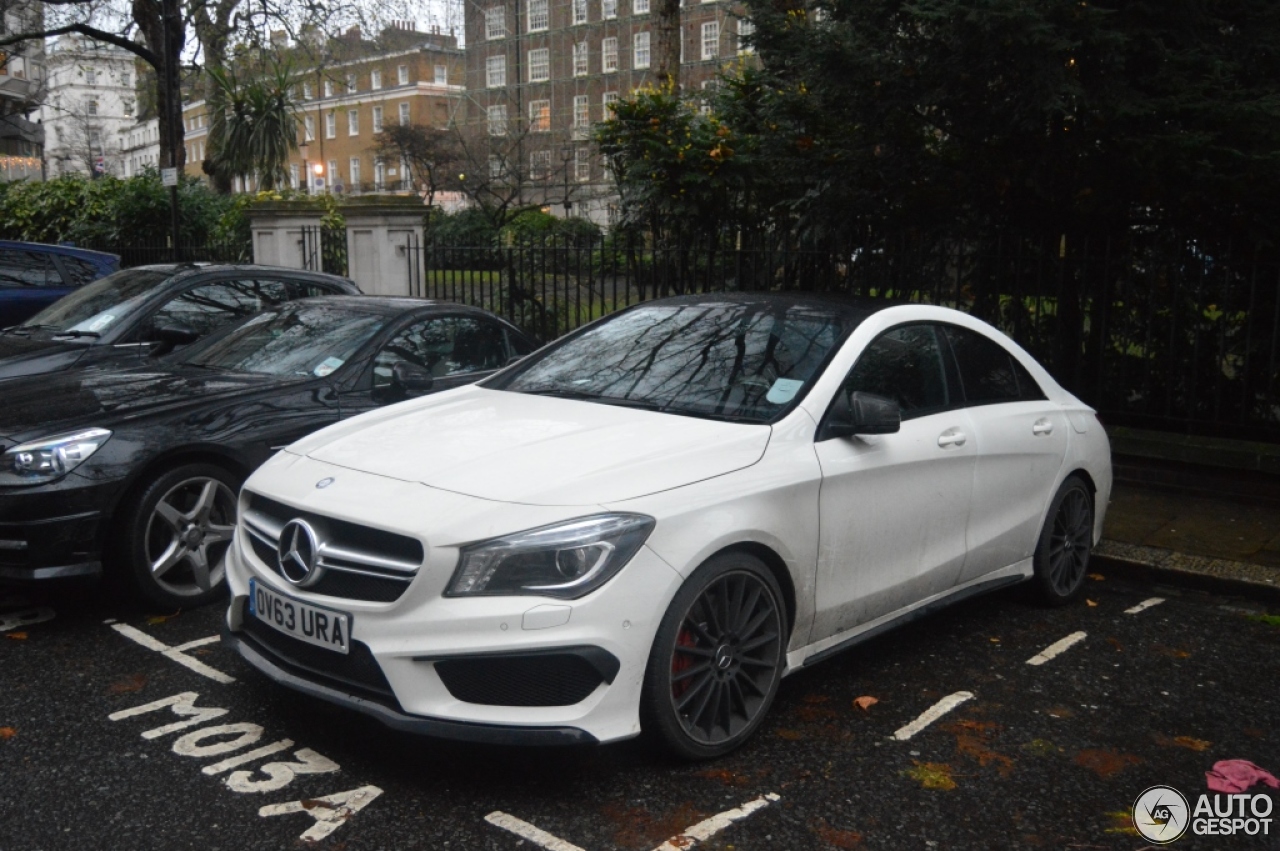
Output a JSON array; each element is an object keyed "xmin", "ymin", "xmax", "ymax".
[{"xmin": 813, "ymin": 324, "xmax": 974, "ymax": 641}]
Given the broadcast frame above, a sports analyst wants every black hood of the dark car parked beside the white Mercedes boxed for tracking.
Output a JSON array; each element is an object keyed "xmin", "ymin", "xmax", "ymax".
[{"xmin": 0, "ymin": 367, "xmax": 281, "ymax": 440}]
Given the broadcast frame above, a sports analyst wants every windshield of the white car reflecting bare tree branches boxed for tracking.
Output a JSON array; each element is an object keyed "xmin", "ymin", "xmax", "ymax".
[{"xmin": 486, "ymin": 299, "xmax": 849, "ymax": 422}]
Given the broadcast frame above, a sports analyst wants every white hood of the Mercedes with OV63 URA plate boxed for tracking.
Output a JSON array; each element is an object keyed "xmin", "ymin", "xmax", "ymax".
[{"xmin": 288, "ymin": 386, "xmax": 771, "ymax": 505}]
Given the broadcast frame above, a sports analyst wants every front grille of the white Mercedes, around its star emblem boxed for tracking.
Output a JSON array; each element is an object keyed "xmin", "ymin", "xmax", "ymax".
[{"xmin": 242, "ymin": 494, "xmax": 424, "ymax": 603}]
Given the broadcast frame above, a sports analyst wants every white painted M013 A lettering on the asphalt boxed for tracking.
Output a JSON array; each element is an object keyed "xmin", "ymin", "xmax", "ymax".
[{"xmin": 108, "ymin": 691, "xmax": 383, "ymax": 842}]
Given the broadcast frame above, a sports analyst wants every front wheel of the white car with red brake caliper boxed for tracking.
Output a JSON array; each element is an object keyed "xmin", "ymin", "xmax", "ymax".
[{"xmin": 640, "ymin": 553, "xmax": 787, "ymax": 760}]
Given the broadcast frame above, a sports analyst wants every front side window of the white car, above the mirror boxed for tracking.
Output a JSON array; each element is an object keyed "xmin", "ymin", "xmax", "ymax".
[{"xmin": 844, "ymin": 325, "xmax": 947, "ymax": 420}]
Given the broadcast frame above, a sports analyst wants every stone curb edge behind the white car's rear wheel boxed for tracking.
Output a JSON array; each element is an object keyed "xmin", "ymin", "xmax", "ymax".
[{"xmin": 1093, "ymin": 540, "xmax": 1280, "ymax": 603}]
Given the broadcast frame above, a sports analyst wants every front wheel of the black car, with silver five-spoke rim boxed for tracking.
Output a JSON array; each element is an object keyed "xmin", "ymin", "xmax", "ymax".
[{"xmin": 116, "ymin": 463, "xmax": 241, "ymax": 612}]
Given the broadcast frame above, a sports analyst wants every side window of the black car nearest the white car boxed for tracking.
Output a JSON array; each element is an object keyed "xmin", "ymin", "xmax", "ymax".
[{"xmin": 374, "ymin": 316, "xmax": 507, "ymax": 389}]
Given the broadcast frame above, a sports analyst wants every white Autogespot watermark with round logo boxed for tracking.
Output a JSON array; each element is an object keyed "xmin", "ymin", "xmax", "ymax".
[{"xmin": 1133, "ymin": 786, "xmax": 1274, "ymax": 845}]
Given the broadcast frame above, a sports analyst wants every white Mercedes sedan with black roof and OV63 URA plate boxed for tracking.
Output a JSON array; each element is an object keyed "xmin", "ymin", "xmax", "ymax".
[{"xmin": 227, "ymin": 294, "xmax": 1111, "ymax": 759}]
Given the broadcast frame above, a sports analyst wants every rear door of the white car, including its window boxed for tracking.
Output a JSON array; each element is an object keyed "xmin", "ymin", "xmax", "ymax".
[{"xmin": 942, "ymin": 325, "xmax": 1069, "ymax": 582}]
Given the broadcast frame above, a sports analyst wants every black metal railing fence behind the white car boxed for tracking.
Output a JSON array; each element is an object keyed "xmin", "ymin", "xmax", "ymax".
[{"xmin": 407, "ymin": 235, "xmax": 1280, "ymax": 441}]
